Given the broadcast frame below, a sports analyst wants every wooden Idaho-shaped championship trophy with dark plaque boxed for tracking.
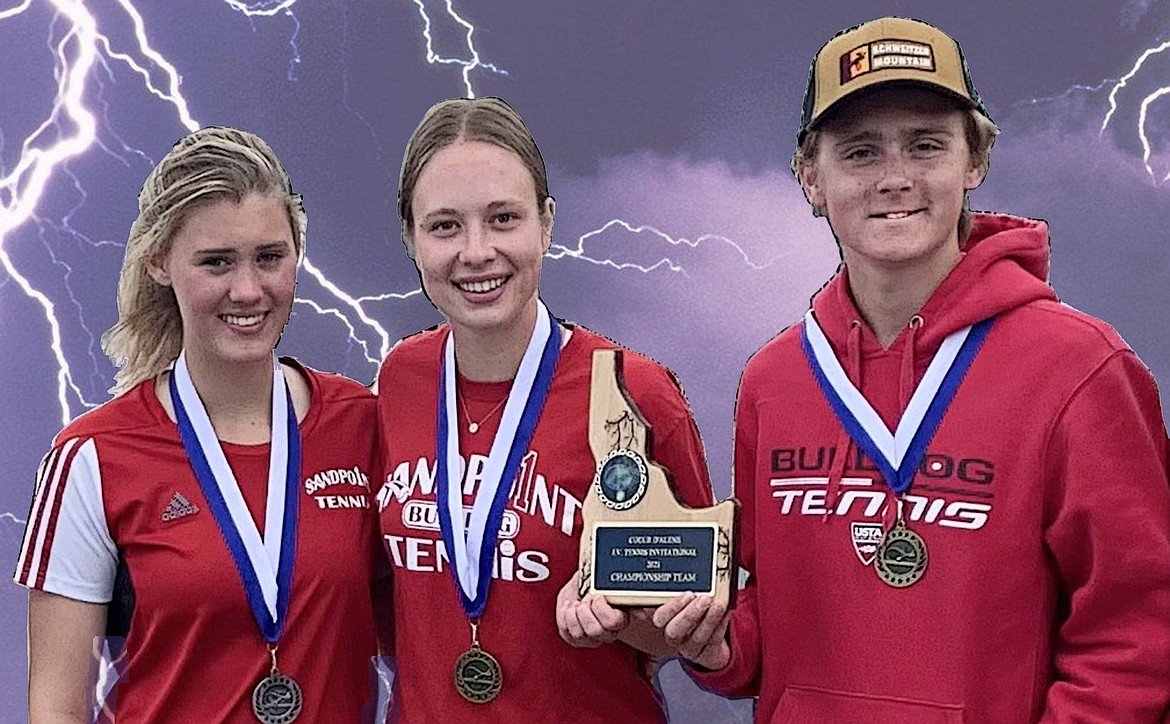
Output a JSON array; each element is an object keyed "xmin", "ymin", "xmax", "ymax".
[{"xmin": 579, "ymin": 350, "xmax": 738, "ymax": 607}]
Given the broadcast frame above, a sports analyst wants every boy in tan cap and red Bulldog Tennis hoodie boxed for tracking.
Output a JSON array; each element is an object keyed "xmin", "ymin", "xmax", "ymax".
[{"xmin": 669, "ymin": 18, "xmax": 1170, "ymax": 724}]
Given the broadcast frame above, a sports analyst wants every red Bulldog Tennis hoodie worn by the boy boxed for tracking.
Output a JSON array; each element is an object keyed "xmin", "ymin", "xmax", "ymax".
[{"xmin": 695, "ymin": 214, "xmax": 1170, "ymax": 724}]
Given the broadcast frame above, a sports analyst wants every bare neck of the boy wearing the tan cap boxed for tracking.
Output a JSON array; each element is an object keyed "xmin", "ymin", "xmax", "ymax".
[{"xmin": 845, "ymin": 244, "xmax": 961, "ymax": 347}]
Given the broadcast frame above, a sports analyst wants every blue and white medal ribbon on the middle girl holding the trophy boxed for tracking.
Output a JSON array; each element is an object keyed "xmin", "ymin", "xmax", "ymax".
[{"xmin": 435, "ymin": 299, "xmax": 560, "ymax": 620}]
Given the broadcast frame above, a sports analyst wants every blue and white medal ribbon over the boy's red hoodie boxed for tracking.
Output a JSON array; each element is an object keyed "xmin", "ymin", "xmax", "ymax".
[{"xmin": 800, "ymin": 310, "xmax": 995, "ymax": 495}]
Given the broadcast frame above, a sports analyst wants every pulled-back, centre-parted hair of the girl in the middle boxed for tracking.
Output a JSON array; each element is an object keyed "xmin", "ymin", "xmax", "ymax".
[{"xmin": 398, "ymin": 96, "xmax": 550, "ymax": 258}]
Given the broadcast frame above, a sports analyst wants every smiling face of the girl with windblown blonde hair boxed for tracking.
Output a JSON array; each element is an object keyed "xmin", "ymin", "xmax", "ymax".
[{"xmin": 147, "ymin": 193, "xmax": 297, "ymax": 374}]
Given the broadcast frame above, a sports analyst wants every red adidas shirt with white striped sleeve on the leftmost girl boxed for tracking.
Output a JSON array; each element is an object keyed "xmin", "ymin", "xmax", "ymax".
[{"xmin": 14, "ymin": 368, "xmax": 380, "ymax": 724}]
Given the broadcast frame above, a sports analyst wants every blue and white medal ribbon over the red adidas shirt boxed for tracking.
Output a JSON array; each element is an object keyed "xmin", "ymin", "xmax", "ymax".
[{"xmin": 171, "ymin": 353, "xmax": 301, "ymax": 646}]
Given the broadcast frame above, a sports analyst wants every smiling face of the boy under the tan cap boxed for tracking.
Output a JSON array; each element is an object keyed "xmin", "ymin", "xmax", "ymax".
[{"xmin": 801, "ymin": 88, "xmax": 985, "ymax": 274}]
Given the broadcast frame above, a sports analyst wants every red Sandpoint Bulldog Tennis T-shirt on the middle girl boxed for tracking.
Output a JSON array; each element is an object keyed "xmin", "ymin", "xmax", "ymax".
[{"xmin": 378, "ymin": 326, "xmax": 713, "ymax": 724}]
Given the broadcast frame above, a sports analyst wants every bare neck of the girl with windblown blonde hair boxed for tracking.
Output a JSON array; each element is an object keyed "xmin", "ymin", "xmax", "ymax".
[{"xmin": 186, "ymin": 350, "xmax": 273, "ymax": 444}]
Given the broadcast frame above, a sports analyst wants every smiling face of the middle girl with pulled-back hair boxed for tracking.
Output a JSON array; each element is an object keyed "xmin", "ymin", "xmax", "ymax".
[{"xmin": 407, "ymin": 140, "xmax": 552, "ymax": 333}]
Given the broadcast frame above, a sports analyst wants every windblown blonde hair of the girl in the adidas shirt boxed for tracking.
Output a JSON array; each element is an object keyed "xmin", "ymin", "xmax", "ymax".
[{"xmin": 102, "ymin": 126, "xmax": 308, "ymax": 395}]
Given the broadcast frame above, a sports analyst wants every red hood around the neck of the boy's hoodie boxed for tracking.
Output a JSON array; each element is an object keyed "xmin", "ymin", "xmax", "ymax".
[{"xmin": 812, "ymin": 213, "xmax": 1057, "ymax": 359}]
